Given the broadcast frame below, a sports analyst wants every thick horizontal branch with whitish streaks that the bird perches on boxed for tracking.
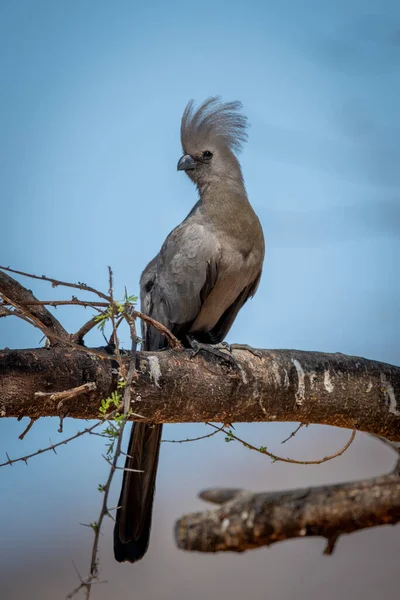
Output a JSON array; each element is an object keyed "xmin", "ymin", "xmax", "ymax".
[{"xmin": 0, "ymin": 347, "xmax": 400, "ymax": 441}]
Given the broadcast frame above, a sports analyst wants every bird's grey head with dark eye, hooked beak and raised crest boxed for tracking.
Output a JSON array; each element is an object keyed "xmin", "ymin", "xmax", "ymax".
[{"xmin": 178, "ymin": 97, "xmax": 247, "ymax": 187}]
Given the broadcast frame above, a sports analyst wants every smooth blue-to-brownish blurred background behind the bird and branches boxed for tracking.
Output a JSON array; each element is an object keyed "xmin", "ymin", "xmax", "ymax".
[{"xmin": 0, "ymin": 0, "xmax": 400, "ymax": 600}]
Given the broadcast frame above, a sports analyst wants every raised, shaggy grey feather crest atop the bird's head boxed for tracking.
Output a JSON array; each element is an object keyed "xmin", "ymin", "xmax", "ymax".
[{"xmin": 181, "ymin": 96, "xmax": 247, "ymax": 153}]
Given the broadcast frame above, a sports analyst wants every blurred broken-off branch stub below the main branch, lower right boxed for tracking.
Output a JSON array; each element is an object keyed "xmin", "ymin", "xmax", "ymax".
[{"xmin": 175, "ymin": 473, "xmax": 400, "ymax": 554}]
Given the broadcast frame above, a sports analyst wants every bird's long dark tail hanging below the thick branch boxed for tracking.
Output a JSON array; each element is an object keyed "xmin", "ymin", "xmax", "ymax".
[{"xmin": 114, "ymin": 423, "xmax": 162, "ymax": 563}]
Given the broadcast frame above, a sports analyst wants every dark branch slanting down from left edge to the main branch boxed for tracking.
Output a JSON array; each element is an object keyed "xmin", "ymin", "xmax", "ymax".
[{"xmin": 0, "ymin": 270, "xmax": 68, "ymax": 338}]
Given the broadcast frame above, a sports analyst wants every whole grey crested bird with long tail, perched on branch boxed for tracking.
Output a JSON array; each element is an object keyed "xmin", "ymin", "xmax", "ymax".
[{"xmin": 114, "ymin": 97, "xmax": 264, "ymax": 562}]
